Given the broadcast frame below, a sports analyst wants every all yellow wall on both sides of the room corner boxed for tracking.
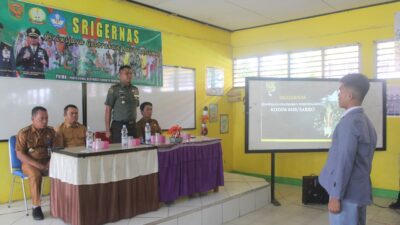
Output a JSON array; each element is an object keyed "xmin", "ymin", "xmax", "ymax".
[{"xmin": 0, "ymin": 0, "xmax": 400, "ymax": 203}]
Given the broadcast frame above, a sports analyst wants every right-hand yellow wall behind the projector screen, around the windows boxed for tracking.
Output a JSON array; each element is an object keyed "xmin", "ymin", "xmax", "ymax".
[{"xmin": 231, "ymin": 3, "xmax": 400, "ymax": 190}]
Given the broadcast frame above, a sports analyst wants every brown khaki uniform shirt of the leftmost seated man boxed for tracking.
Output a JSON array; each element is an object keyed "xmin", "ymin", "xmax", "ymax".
[{"xmin": 16, "ymin": 125, "xmax": 58, "ymax": 163}]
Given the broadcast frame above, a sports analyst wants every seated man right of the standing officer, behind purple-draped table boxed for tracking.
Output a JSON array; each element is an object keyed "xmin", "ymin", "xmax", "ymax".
[{"xmin": 136, "ymin": 102, "xmax": 161, "ymax": 138}]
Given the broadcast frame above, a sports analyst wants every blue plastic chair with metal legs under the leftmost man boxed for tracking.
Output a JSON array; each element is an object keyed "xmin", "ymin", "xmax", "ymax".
[{"xmin": 8, "ymin": 135, "xmax": 29, "ymax": 216}]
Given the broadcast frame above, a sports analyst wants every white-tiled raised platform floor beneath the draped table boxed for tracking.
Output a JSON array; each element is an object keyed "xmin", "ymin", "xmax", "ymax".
[{"xmin": 0, "ymin": 173, "xmax": 269, "ymax": 225}]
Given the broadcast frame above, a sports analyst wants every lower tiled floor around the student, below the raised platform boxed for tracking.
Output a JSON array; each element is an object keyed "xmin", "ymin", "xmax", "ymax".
[{"xmin": 226, "ymin": 184, "xmax": 400, "ymax": 225}]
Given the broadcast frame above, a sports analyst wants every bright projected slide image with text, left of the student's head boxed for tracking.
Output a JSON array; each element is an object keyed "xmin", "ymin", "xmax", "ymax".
[{"xmin": 261, "ymin": 82, "xmax": 342, "ymax": 142}]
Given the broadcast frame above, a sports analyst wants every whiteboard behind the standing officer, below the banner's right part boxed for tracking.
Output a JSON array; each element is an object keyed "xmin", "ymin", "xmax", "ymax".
[{"xmin": 87, "ymin": 66, "xmax": 196, "ymax": 131}]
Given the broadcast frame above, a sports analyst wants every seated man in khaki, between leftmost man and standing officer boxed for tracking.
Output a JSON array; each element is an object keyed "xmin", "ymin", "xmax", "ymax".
[{"xmin": 56, "ymin": 105, "xmax": 86, "ymax": 147}]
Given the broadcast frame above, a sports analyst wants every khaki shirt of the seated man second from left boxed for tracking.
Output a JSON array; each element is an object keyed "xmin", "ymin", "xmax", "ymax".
[{"xmin": 56, "ymin": 122, "xmax": 86, "ymax": 147}]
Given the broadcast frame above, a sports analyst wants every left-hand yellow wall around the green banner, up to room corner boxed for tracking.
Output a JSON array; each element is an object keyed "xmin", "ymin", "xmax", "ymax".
[{"xmin": 0, "ymin": 0, "xmax": 232, "ymax": 203}]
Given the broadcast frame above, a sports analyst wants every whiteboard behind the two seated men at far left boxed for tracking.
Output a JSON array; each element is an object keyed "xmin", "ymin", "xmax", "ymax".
[{"xmin": 0, "ymin": 77, "xmax": 82, "ymax": 140}]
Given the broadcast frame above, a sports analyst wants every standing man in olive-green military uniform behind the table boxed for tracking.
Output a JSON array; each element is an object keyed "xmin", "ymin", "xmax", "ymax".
[{"xmin": 104, "ymin": 65, "xmax": 139, "ymax": 143}]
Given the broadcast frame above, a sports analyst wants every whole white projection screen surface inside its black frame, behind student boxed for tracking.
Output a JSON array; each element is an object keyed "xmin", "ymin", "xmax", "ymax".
[{"xmin": 246, "ymin": 78, "xmax": 385, "ymax": 152}]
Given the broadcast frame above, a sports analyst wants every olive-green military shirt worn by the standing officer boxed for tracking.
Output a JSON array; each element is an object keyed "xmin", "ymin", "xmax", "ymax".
[{"xmin": 104, "ymin": 83, "xmax": 139, "ymax": 122}]
